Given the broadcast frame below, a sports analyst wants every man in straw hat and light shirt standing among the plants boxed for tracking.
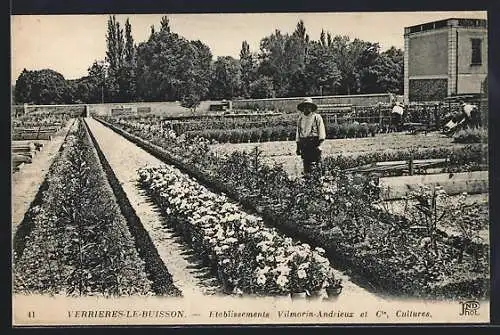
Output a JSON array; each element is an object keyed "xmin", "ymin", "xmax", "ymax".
[{"xmin": 295, "ymin": 98, "xmax": 326, "ymax": 175}]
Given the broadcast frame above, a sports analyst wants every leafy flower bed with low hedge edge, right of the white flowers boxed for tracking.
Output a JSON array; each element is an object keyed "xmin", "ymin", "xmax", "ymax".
[{"xmin": 96, "ymin": 117, "xmax": 489, "ymax": 298}]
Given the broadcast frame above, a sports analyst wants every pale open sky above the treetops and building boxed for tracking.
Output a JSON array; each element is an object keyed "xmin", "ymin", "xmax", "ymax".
[{"xmin": 11, "ymin": 11, "xmax": 487, "ymax": 83}]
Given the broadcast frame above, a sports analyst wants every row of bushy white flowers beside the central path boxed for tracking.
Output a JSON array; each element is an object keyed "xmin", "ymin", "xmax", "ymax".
[{"xmin": 139, "ymin": 165, "xmax": 338, "ymax": 294}]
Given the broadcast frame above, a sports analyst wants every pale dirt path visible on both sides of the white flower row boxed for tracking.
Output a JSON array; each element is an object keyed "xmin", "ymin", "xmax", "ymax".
[{"xmin": 87, "ymin": 119, "xmax": 384, "ymax": 302}]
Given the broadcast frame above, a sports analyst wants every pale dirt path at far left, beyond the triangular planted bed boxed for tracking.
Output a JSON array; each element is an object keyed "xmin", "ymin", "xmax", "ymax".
[{"xmin": 11, "ymin": 120, "xmax": 73, "ymax": 233}]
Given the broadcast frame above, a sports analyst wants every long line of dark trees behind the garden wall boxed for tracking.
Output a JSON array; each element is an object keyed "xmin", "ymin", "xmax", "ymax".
[{"xmin": 14, "ymin": 16, "xmax": 403, "ymax": 108}]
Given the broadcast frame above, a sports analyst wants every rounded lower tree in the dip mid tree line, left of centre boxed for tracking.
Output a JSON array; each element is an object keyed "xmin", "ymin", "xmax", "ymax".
[{"xmin": 210, "ymin": 56, "xmax": 241, "ymax": 99}]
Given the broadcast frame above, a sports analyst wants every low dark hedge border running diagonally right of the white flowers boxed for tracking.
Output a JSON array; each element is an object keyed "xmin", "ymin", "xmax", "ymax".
[{"xmin": 96, "ymin": 119, "xmax": 490, "ymax": 298}]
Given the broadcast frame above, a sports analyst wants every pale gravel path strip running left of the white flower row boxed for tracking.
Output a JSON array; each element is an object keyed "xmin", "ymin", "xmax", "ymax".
[{"xmin": 86, "ymin": 118, "xmax": 220, "ymax": 297}]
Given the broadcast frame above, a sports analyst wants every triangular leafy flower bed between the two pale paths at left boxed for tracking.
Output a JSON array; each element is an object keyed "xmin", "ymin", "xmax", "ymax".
[{"xmin": 13, "ymin": 121, "xmax": 157, "ymax": 296}]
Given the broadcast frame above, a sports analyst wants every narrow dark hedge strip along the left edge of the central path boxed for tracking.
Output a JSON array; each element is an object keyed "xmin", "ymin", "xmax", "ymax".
[{"xmin": 84, "ymin": 121, "xmax": 182, "ymax": 296}]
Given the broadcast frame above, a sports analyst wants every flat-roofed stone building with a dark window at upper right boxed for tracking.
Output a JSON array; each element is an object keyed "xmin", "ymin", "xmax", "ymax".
[{"xmin": 404, "ymin": 19, "xmax": 488, "ymax": 103}]
